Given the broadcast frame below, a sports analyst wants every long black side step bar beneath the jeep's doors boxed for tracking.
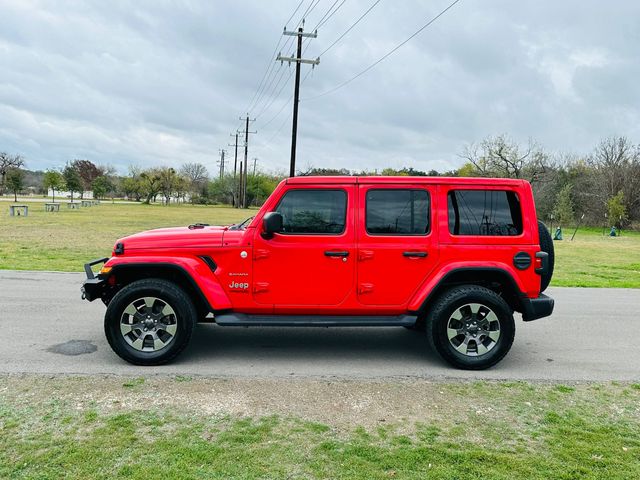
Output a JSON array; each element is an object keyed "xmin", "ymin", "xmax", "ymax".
[{"xmin": 215, "ymin": 313, "xmax": 418, "ymax": 327}]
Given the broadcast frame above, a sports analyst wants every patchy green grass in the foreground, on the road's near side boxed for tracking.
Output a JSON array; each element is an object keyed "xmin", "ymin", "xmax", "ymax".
[{"xmin": 0, "ymin": 377, "xmax": 640, "ymax": 480}]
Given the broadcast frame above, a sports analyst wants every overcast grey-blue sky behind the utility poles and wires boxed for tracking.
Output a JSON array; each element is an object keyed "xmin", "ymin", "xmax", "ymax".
[{"xmin": 0, "ymin": 0, "xmax": 640, "ymax": 173}]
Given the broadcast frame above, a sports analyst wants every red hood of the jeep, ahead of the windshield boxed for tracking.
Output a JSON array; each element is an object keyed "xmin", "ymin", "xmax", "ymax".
[{"xmin": 116, "ymin": 226, "xmax": 228, "ymax": 254}]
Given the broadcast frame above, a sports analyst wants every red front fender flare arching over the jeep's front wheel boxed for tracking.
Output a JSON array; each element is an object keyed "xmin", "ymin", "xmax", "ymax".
[{"xmin": 105, "ymin": 255, "xmax": 231, "ymax": 311}]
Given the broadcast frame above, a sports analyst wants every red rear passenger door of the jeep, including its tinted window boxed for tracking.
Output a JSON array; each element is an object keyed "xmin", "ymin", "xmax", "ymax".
[{"xmin": 357, "ymin": 184, "xmax": 438, "ymax": 305}]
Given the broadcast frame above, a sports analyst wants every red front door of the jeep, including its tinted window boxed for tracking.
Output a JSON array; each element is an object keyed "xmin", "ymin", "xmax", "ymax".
[{"xmin": 253, "ymin": 185, "xmax": 355, "ymax": 313}]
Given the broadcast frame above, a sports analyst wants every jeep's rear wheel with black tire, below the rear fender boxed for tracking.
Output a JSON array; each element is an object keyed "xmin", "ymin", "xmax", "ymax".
[{"xmin": 426, "ymin": 285, "xmax": 516, "ymax": 370}]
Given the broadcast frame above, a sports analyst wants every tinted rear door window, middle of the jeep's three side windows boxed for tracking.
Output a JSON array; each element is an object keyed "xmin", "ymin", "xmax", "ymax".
[{"xmin": 366, "ymin": 189, "xmax": 429, "ymax": 235}]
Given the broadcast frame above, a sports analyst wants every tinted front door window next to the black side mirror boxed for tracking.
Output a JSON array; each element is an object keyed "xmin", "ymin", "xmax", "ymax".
[{"xmin": 276, "ymin": 190, "xmax": 347, "ymax": 233}]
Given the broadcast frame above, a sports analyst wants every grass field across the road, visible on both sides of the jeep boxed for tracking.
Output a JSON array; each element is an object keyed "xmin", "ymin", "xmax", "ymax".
[{"xmin": 0, "ymin": 202, "xmax": 640, "ymax": 288}]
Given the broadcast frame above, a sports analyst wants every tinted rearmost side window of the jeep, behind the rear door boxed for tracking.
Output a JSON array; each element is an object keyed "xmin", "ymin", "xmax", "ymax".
[{"xmin": 448, "ymin": 190, "xmax": 522, "ymax": 236}]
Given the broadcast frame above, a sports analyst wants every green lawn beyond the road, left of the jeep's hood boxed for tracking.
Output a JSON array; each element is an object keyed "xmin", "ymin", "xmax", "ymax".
[{"xmin": 0, "ymin": 202, "xmax": 254, "ymax": 272}]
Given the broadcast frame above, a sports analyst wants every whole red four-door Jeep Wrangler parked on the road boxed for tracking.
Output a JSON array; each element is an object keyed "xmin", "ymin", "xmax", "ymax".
[{"xmin": 82, "ymin": 177, "xmax": 554, "ymax": 369}]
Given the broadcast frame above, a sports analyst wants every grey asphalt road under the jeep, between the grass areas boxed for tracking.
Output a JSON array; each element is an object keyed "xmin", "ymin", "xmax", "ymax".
[{"xmin": 0, "ymin": 271, "xmax": 640, "ymax": 381}]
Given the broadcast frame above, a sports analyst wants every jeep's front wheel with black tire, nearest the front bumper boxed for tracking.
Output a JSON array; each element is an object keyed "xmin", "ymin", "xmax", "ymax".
[{"xmin": 104, "ymin": 279, "xmax": 197, "ymax": 365}]
